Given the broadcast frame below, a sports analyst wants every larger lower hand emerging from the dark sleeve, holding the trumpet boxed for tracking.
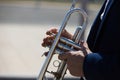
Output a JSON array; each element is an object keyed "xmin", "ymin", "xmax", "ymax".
[{"xmin": 58, "ymin": 42, "xmax": 91, "ymax": 77}]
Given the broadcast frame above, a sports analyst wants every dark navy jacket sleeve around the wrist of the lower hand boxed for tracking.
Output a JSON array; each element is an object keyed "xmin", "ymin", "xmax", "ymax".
[{"xmin": 83, "ymin": 53, "xmax": 120, "ymax": 80}]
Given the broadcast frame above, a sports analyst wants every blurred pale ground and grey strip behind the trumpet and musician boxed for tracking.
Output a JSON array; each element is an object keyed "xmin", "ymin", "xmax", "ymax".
[{"xmin": 0, "ymin": 0, "xmax": 104, "ymax": 80}]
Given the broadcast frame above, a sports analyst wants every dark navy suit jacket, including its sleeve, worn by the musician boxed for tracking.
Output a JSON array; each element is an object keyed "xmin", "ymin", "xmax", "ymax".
[{"xmin": 84, "ymin": 0, "xmax": 120, "ymax": 80}]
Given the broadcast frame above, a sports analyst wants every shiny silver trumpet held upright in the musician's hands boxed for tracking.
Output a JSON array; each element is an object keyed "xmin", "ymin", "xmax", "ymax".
[{"xmin": 37, "ymin": 0, "xmax": 87, "ymax": 80}]
